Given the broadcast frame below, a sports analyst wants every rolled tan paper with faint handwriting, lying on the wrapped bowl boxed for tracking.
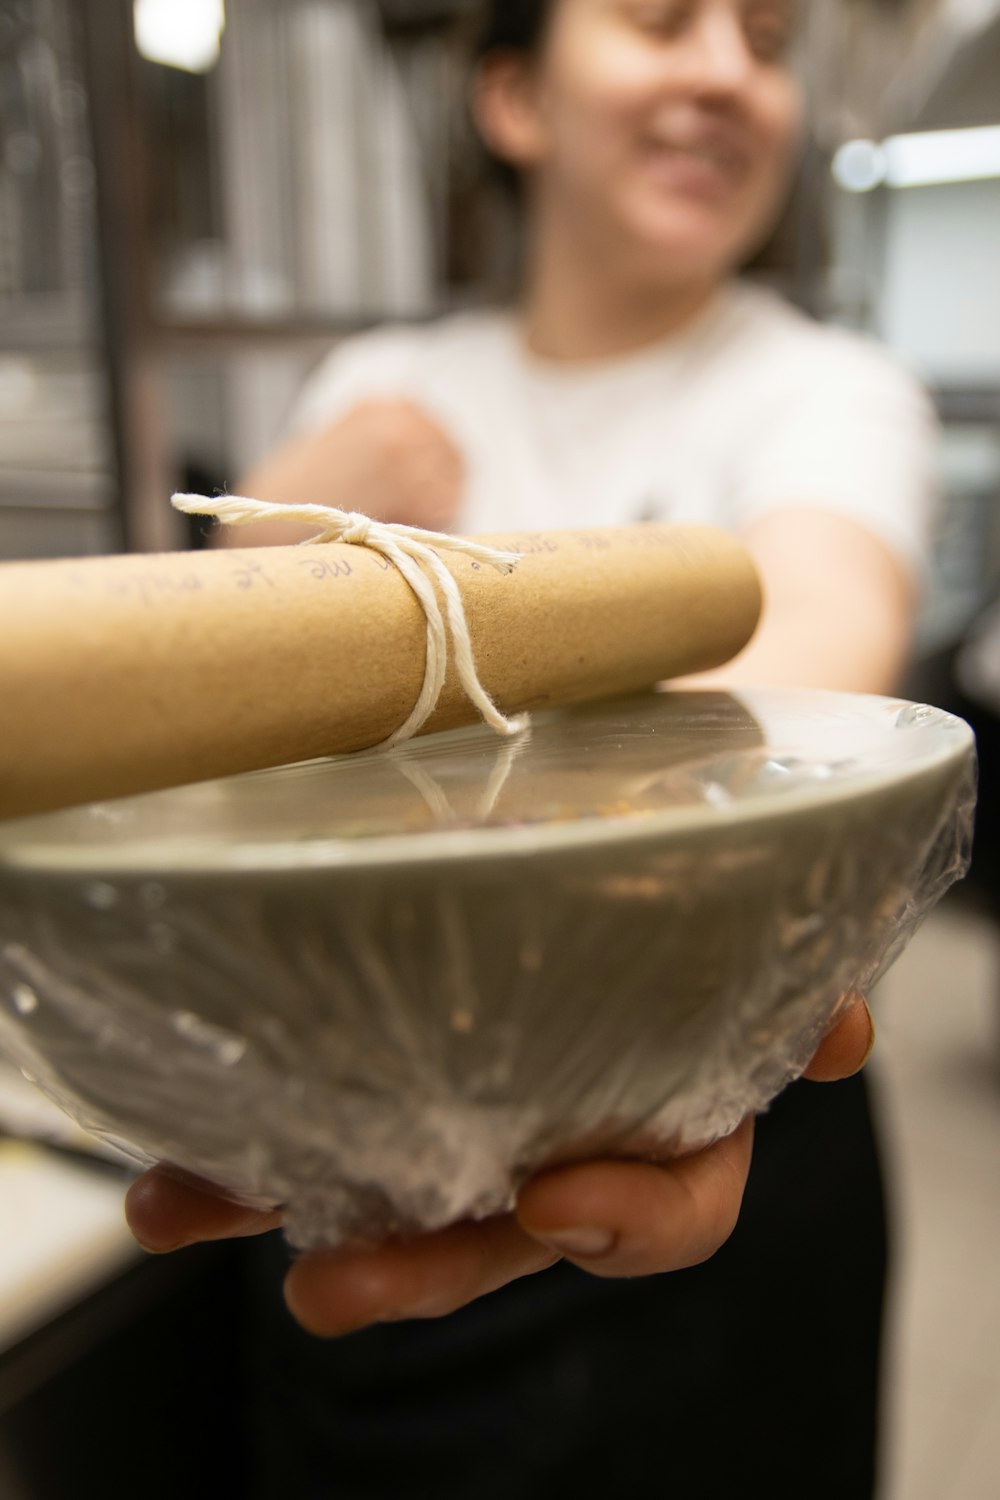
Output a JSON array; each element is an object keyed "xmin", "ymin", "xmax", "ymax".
[{"xmin": 0, "ymin": 525, "xmax": 760, "ymax": 818}]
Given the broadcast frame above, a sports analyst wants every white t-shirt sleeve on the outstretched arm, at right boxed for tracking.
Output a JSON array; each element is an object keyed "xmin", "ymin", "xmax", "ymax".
[{"xmin": 730, "ymin": 336, "xmax": 937, "ymax": 578}]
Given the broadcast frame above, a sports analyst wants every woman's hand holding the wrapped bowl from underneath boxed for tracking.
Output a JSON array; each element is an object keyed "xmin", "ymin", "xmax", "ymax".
[{"xmin": 126, "ymin": 998, "xmax": 874, "ymax": 1338}]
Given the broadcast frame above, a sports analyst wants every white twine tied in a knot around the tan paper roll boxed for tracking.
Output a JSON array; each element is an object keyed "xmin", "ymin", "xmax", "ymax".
[{"xmin": 172, "ymin": 495, "xmax": 529, "ymax": 749}]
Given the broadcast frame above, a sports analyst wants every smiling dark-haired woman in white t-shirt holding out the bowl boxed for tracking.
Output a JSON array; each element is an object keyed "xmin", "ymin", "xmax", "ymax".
[{"xmin": 130, "ymin": 0, "xmax": 933, "ymax": 1500}]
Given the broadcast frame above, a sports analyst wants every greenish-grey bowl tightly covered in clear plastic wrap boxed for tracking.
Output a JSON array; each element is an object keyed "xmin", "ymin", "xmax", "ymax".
[{"xmin": 0, "ymin": 692, "xmax": 975, "ymax": 1247}]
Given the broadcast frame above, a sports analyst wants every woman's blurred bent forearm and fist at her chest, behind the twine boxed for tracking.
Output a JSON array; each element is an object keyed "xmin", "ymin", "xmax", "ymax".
[{"xmin": 222, "ymin": 399, "xmax": 465, "ymax": 548}]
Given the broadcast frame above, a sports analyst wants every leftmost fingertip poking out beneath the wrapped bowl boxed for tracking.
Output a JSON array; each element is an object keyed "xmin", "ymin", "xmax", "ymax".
[{"xmin": 124, "ymin": 1167, "xmax": 282, "ymax": 1256}]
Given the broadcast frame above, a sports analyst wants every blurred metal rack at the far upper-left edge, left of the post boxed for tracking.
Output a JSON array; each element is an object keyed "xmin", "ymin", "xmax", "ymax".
[{"xmin": 0, "ymin": 0, "xmax": 120, "ymax": 557}]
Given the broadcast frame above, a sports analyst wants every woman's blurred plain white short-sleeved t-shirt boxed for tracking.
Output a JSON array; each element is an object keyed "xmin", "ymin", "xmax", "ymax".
[{"xmin": 294, "ymin": 282, "xmax": 936, "ymax": 572}]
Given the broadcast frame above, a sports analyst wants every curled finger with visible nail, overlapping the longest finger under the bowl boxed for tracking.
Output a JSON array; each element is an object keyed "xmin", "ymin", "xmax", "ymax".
[{"xmin": 517, "ymin": 1119, "xmax": 754, "ymax": 1277}]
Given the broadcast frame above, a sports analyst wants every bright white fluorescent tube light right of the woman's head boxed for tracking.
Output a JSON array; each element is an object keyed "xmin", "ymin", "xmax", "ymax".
[{"xmin": 832, "ymin": 125, "xmax": 1000, "ymax": 192}]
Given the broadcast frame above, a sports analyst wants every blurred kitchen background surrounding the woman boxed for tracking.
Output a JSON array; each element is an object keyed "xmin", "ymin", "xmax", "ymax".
[{"xmin": 0, "ymin": 0, "xmax": 1000, "ymax": 1500}]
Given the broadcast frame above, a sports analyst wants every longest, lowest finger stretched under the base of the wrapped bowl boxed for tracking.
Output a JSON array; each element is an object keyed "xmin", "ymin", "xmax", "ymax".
[{"xmin": 285, "ymin": 1217, "xmax": 559, "ymax": 1338}]
